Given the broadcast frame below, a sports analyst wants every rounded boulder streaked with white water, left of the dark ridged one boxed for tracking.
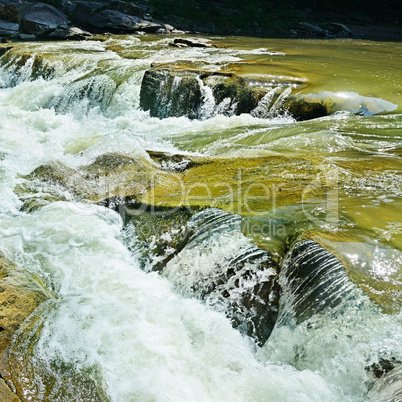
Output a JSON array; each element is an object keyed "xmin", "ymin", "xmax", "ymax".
[{"xmin": 162, "ymin": 209, "xmax": 279, "ymax": 345}]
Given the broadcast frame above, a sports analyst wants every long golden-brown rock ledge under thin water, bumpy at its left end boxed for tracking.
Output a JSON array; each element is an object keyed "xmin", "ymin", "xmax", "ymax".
[{"xmin": 18, "ymin": 150, "xmax": 327, "ymax": 216}]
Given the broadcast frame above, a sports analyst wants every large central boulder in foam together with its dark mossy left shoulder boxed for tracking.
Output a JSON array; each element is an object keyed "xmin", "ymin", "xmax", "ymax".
[{"xmin": 120, "ymin": 205, "xmax": 279, "ymax": 345}]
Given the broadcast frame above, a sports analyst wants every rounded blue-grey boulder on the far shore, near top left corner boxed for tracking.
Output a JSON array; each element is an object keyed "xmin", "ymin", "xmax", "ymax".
[{"xmin": 20, "ymin": 3, "xmax": 70, "ymax": 37}]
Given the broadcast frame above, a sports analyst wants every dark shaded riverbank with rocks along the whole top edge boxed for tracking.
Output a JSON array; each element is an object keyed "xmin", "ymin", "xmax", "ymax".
[{"xmin": 0, "ymin": 0, "xmax": 402, "ymax": 42}]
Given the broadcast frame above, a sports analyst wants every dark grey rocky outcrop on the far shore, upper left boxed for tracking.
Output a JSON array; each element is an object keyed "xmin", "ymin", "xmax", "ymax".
[{"xmin": 0, "ymin": 0, "xmax": 175, "ymax": 40}]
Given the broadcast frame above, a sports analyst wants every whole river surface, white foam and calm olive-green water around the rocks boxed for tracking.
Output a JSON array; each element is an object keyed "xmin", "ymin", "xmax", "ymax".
[{"xmin": 0, "ymin": 36, "xmax": 402, "ymax": 401}]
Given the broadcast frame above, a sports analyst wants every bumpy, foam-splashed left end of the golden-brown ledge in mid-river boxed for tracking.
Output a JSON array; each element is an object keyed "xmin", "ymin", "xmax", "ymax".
[{"xmin": 14, "ymin": 153, "xmax": 170, "ymax": 207}]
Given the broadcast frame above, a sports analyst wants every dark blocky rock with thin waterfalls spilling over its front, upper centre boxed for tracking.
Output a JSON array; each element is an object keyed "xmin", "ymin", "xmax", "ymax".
[{"xmin": 140, "ymin": 61, "xmax": 303, "ymax": 119}]
